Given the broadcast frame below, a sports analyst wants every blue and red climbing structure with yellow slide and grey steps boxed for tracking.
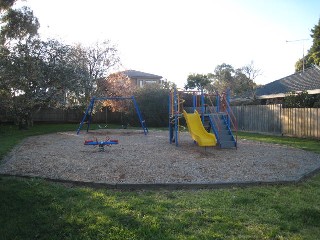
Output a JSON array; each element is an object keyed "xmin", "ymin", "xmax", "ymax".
[{"xmin": 169, "ymin": 89, "xmax": 238, "ymax": 148}]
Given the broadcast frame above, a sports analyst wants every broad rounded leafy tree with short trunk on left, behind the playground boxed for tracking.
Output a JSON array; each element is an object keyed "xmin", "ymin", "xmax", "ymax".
[{"xmin": 0, "ymin": 39, "xmax": 85, "ymax": 126}]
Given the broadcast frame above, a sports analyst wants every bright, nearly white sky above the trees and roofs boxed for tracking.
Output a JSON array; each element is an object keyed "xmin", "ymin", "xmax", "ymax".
[{"xmin": 19, "ymin": 0, "xmax": 320, "ymax": 87}]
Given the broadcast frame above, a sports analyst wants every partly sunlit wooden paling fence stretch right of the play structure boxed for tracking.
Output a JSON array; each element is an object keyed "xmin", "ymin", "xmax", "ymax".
[{"xmin": 232, "ymin": 104, "xmax": 320, "ymax": 139}]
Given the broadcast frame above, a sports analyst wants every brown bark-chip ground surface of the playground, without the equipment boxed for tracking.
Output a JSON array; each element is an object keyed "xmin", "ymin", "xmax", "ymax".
[{"xmin": 0, "ymin": 129, "xmax": 320, "ymax": 185}]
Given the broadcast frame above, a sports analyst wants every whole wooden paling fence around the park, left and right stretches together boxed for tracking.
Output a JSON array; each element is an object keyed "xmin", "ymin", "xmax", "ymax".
[{"xmin": 0, "ymin": 104, "xmax": 320, "ymax": 139}]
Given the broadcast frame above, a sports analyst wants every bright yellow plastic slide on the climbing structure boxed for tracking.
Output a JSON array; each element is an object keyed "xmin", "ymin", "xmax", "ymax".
[{"xmin": 183, "ymin": 110, "xmax": 217, "ymax": 147}]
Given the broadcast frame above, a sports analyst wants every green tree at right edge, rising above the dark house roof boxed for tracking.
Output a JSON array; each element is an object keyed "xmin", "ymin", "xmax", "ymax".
[{"xmin": 295, "ymin": 19, "xmax": 320, "ymax": 72}]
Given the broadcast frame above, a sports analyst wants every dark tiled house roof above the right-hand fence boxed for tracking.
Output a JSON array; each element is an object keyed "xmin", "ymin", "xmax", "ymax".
[{"xmin": 256, "ymin": 65, "xmax": 320, "ymax": 98}]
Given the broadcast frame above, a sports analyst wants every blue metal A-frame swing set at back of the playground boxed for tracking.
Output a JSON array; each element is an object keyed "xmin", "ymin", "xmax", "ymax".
[{"xmin": 77, "ymin": 96, "xmax": 148, "ymax": 135}]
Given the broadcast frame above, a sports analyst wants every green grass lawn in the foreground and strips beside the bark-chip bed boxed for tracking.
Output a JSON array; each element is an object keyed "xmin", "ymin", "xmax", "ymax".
[{"xmin": 0, "ymin": 125, "xmax": 320, "ymax": 239}]
